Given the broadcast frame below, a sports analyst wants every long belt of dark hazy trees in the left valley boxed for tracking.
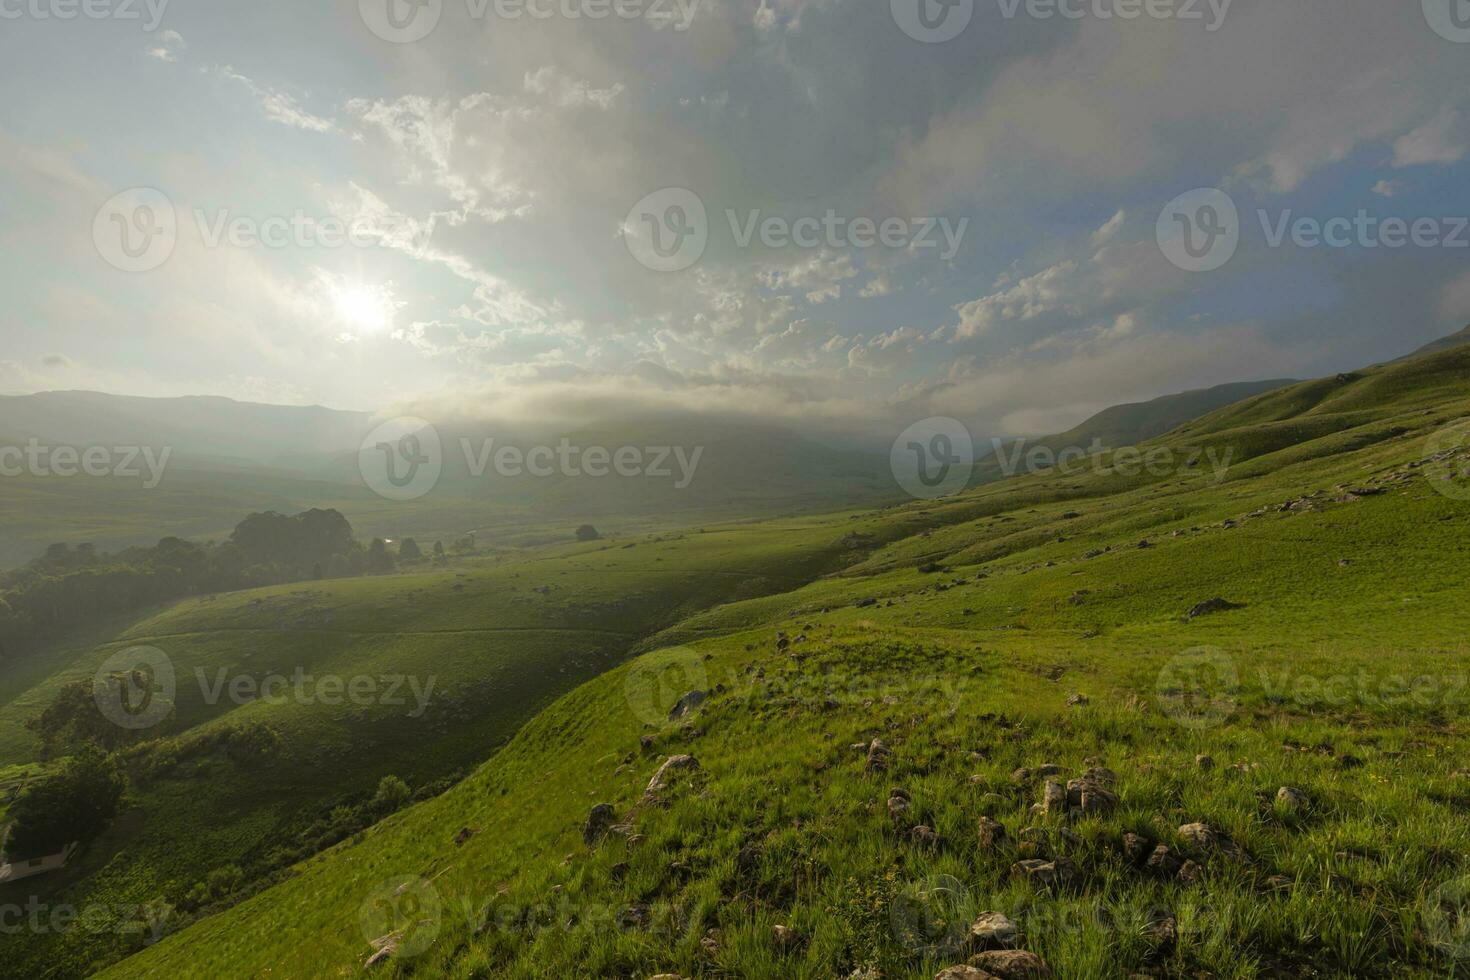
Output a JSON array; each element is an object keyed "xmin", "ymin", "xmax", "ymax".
[{"xmin": 0, "ymin": 510, "xmax": 397, "ymax": 654}]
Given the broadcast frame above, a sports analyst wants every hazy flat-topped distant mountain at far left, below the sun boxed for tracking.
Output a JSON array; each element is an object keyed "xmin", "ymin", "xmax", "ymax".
[{"xmin": 0, "ymin": 391, "xmax": 370, "ymax": 470}]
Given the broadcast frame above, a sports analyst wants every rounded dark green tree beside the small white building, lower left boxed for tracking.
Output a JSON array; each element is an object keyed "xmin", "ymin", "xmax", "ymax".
[{"xmin": 6, "ymin": 748, "xmax": 126, "ymax": 861}]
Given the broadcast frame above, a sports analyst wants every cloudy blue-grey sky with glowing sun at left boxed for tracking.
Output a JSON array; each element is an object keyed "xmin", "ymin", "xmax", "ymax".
[{"xmin": 0, "ymin": 0, "xmax": 1470, "ymax": 438}]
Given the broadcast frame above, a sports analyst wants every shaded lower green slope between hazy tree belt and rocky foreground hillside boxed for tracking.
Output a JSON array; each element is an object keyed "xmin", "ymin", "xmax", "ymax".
[{"xmin": 0, "ymin": 516, "xmax": 929, "ymax": 977}]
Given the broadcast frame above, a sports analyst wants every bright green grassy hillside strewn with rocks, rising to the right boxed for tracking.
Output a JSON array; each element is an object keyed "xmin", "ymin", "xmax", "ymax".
[{"xmin": 88, "ymin": 351, "xmax": 1470, "ymax": 979}]
